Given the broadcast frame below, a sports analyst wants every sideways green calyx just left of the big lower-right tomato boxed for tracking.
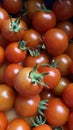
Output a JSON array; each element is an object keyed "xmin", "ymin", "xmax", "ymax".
[{"xmin": 38, "ymin": 100, "xmax": 48, "ymax": 116}]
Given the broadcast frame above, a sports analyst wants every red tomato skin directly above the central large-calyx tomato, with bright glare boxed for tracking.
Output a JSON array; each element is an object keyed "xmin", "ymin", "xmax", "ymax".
[{"xmin": 23, "ymin": 52, "xmax": 49, "ymax": 69}]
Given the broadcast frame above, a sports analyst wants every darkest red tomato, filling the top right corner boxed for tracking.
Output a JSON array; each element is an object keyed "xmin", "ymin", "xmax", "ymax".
[{"xmin": 52, "ymin": 0, "xmax": 73, "ymax": 21}]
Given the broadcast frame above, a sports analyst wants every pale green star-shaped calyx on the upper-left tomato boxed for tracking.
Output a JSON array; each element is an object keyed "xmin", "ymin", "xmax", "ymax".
[{"xmin": 10, "ymin": 17, "xmax": 24, "ymax": 32}]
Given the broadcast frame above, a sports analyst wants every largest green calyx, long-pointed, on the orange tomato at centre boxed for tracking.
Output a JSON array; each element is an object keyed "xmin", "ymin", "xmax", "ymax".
[{"xmin": 29, "ymin": 64, "xmax": 48, "ymax": 87}]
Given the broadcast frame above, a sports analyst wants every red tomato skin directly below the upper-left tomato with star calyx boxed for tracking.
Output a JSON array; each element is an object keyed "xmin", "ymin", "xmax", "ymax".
[{"xmin": 5, "ymin": 42, "xmax": 27, "ymax": 63}]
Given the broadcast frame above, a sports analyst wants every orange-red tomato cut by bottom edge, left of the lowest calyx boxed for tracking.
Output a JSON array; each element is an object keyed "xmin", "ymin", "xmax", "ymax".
[{"xmin": 6, "ymin": 118, "xmax": 31, "ymax": 130}]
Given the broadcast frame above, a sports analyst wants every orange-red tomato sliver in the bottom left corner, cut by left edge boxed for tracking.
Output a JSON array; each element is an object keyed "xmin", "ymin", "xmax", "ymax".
[{"xmin": 0, "ymin": 111, "xmax": 8, "ymax": 130}]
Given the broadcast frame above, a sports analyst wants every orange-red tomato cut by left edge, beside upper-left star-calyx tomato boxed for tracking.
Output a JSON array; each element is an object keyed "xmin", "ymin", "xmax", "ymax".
[{"xmin": 0, "ymin": 7, "xmax": 9, "ymax": 30}]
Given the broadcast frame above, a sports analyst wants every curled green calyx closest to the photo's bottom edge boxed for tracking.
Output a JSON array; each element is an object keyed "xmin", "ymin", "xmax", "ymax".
[{"xmin": 31, "ymin": 115, "xmax": 46, "ymax": 127}]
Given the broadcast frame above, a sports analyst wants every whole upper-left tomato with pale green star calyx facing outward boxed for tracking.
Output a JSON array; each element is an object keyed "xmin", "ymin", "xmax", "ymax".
[{"xmin": 1, "ymin": 18, "xmax": 27, "ymax": 42}]
